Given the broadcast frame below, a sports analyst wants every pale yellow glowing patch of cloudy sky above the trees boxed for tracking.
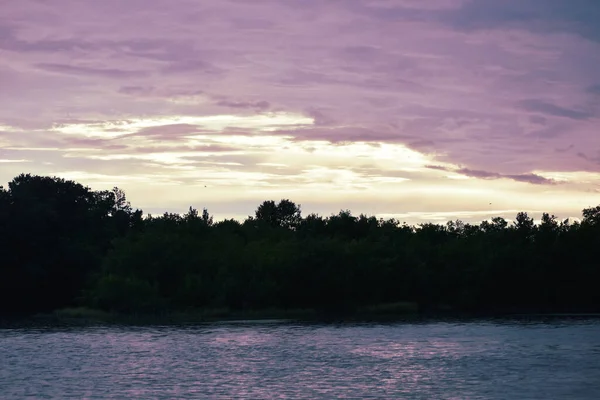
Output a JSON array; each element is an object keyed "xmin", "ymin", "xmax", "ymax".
[{"xmin": 0, "ymin": 109, "xmax": 600, "ymax": 222}]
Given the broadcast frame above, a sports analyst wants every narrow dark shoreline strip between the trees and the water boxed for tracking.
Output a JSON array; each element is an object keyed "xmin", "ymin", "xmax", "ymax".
[{"xmin": 0, "ymin": 303, "xmax": 600, "ymax": 328}]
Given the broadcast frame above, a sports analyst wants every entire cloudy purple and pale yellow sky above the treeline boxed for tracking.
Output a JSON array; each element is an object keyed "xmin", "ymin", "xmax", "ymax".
[{"xmin": 0, "ymin": 0, "xmax": 600, "ymax": 223}]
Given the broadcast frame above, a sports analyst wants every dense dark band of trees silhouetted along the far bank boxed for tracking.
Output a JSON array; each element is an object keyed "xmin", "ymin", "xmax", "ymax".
[{"xmin": 0, "ymin": 175, "xmax": 600, "ymax": 314}]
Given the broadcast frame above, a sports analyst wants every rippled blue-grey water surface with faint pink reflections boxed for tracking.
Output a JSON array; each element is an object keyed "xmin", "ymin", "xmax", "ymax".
[{"xmin": 0, "ymin": 319, "xmax": 600, "ymax": 400}]
